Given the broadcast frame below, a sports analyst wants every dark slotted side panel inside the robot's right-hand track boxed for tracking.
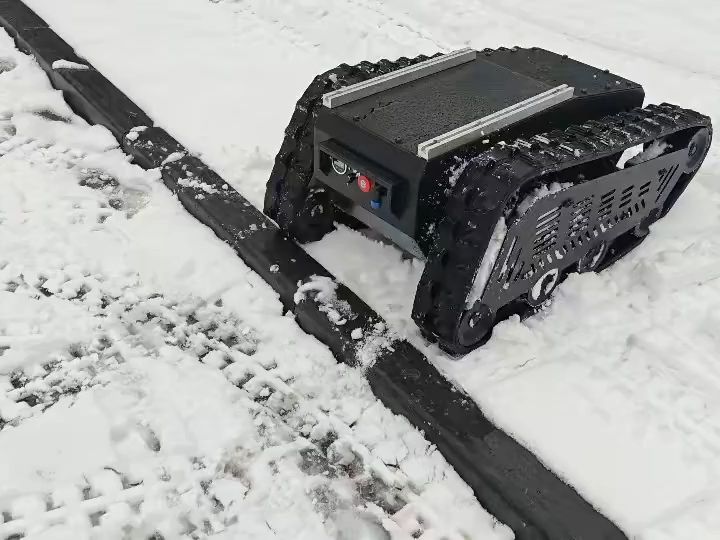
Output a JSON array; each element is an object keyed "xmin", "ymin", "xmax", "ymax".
[{"xmin": 482, "ymin": 151, "xmax": 684, "ymax": 308}]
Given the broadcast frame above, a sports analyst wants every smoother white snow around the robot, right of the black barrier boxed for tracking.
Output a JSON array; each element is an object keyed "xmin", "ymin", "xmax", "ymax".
[{"xmin": 7, "ymin": 0, "xmax": 720, "ymax": 540}]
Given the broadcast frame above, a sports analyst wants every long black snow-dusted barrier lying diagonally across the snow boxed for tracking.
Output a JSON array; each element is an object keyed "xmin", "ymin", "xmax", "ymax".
[{"xmin": 0, "ymin": 0, "xmax": 626, "ymax": 540}]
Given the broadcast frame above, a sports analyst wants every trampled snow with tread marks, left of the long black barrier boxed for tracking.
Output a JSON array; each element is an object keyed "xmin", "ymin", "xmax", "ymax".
[{"xmin": 0, "ymin": 32, "xmax": 512, "ymax": 540}]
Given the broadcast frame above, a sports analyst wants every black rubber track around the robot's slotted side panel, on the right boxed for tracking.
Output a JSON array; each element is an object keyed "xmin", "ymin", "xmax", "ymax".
[{"xmin": 413, "ymin": 103, "xmax": 712, "ymax": 354}]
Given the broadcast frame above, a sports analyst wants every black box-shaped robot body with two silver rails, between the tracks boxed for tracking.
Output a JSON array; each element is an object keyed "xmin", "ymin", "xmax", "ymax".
[{"xmin": 312, "ymin": 48, "xmax": 644, "ymax": 259}]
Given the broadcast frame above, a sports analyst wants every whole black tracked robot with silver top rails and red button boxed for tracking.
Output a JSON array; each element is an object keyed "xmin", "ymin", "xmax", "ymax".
[{"xmin": 265, "ymin": 48, "xmax": 712, "ymax": 354}]
